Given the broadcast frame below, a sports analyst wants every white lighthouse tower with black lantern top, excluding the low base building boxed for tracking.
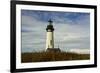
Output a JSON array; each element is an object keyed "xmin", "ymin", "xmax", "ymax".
[{"xmin": 46, "ymin": 20, "xmax": 54, "ymax": 50}]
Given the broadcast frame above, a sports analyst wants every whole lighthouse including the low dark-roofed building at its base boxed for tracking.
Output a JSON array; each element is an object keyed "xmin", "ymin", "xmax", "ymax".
[{"xmin": 46, "ymin": 20, "xmax": 61, "ymax": 52}]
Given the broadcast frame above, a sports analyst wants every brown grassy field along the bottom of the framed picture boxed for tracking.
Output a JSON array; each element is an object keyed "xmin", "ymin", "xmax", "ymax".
[{"xmin": 21, "ymin": 52, "xmax": 90, "ymax": 63}]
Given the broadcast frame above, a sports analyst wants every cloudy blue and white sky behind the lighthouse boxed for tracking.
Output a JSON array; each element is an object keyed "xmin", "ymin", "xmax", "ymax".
[{"xmin": 21, "ymin": 10, "xmax": 90, "ymax": 53}]
